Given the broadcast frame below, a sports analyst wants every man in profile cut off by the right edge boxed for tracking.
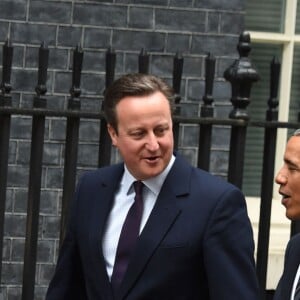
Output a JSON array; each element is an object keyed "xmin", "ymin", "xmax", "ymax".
[{"xmin": 274, "ymin": 129, "xmax": 300, "ymax": 300}]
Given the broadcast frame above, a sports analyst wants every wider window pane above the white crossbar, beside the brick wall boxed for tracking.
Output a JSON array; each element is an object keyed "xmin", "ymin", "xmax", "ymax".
[{"xmin": 245, "ymin": 0, "xmax": 285, "ymax": 33}]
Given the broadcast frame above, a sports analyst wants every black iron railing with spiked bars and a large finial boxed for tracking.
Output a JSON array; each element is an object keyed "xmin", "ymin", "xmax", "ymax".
[{"xmin": 0, "ymin": 33, "xmax": 300, "ymax": 300}]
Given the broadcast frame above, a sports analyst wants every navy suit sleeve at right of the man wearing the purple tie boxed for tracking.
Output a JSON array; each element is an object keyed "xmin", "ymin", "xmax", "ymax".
[{"xmin": 204, "ymin": 188, "xmax": 259, "ymax": 300}]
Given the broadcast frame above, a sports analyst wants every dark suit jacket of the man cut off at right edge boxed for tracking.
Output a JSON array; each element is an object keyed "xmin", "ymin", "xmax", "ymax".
[{"xmin": 274, "ymin": 234, "xmax": 300, "ymax": 300}]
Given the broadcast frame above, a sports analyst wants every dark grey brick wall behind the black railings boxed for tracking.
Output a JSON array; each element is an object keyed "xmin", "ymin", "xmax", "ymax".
[{"xmin": 0, "ymin": 0, "xmax": 244, "ymax": 300}]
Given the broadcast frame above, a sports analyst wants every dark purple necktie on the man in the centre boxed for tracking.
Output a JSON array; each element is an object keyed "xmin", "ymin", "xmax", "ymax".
[{"xmin": 111, "ymin": 181, "xmax": 144, "ymax": 291}]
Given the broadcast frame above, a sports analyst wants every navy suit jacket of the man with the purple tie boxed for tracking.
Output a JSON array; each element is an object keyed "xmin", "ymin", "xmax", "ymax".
[{"xmin": 46, "ymin": 156, "xmax": 258, "ymax": 300}]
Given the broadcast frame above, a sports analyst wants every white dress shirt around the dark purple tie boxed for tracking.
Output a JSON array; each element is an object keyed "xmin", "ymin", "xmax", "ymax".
[{"xmin": 102, "ymin": 155, "xmax": 175, "ymax": 278}]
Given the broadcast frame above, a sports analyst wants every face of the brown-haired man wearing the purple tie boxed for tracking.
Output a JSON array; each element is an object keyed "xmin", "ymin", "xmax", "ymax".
[{"xmin": 108, "ymin": 92, "xmax": 174, "ymax": 180}]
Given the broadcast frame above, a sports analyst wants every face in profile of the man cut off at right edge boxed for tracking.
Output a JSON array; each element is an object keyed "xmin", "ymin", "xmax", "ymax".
[{"xmin": 275, "ymin": 136, "xmax": 300, "ymax": 220}]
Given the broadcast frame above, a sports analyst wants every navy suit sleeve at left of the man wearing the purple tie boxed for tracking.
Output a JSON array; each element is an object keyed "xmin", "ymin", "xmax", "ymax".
[{"xmin": 46, "ymin": 178, "xmax": 87, "ymax": 300}]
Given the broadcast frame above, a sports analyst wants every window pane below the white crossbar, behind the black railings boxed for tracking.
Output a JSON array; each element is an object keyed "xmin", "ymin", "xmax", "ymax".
[{"xmin": 243, "ymin": 44, "xmax": 282, "ymax": 197}]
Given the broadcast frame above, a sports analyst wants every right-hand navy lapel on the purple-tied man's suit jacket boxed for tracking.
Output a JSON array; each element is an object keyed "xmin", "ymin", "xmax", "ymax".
[{"xmin": 116, "ymin": 158, "xmax": 190, "ymax": 299}]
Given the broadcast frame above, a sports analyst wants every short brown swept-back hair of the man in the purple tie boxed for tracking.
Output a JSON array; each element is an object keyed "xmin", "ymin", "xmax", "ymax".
[{"xmin": 103, "ymin": 73, "xmax": 174, "ymax": 131}]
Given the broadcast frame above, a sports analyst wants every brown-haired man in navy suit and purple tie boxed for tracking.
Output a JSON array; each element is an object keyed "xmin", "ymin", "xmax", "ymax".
[{"xmin": 46, "ymin": 74, "xmax": 258, "ymax": 300}]
